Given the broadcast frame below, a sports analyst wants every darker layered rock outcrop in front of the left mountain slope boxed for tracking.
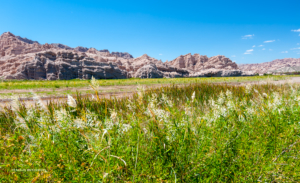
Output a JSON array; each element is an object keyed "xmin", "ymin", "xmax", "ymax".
[{"xmin": 6, "ymin": 52, "xmax": 127, "ymax": 80}]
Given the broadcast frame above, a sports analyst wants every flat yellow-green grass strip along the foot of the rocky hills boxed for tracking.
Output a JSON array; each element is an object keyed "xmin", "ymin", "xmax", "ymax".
[{"xmin": 0, "ymin": 75, "xmax": 290, "ymax": 90}]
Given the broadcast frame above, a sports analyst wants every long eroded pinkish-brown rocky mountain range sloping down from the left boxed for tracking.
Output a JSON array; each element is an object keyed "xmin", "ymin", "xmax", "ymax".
[{"xmin": 0, "ymin": 32, "xmax": 251, "ymax": 80}]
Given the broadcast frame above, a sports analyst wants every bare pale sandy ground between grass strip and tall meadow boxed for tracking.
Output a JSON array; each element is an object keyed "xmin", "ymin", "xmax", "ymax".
[{"xmin": 0, "ymin": 77, "xmax": 300, "ymax": 106}]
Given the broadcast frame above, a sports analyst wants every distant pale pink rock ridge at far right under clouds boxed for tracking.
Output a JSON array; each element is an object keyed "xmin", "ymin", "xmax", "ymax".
[{"xmin": 238, "ymin": 58, "xmax": 300, "ymax": 74}]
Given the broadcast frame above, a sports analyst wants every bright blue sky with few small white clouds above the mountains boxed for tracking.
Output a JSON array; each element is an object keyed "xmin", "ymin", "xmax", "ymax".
[{"xmin": 0, "ymin": 0, "xmax": 300, "ymax": 64}]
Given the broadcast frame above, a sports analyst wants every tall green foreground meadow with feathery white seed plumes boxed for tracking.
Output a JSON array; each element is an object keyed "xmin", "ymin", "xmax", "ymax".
[{"xmin": 0, "ymin": 78, "xmax": 300, "ymax": 182}]
